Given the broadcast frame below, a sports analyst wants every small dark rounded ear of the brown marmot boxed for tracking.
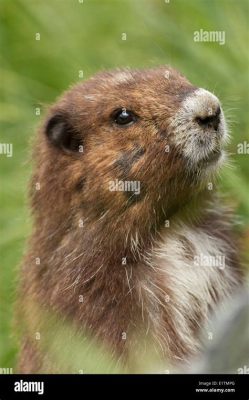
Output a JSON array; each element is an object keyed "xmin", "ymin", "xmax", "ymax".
[{"xmin": 45, "ymin": 114, "xmax": 83, "ymax": 152}]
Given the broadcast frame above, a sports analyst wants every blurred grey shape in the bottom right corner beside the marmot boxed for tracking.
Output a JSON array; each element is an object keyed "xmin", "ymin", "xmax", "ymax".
[{"xmin": 190, "ymin": 287, "xmax": 249, "ymax": 374}]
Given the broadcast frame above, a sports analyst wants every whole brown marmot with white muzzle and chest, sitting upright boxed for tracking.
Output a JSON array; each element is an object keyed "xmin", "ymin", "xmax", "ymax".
[{"xmin": 19, "ymin": 66, "xmax": 241, "ymax": 373}]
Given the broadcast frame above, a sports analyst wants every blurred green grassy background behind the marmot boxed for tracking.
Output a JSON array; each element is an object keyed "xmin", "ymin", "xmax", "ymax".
[{"xmin": 0, "ymin": 0, "xmax": 249, "ymax": 368}]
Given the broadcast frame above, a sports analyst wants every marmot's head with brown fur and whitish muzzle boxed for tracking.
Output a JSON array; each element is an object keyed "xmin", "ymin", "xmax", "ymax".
[{"xmin": 35, "ymin": 67, "xmax": 228, "ymax": 234}]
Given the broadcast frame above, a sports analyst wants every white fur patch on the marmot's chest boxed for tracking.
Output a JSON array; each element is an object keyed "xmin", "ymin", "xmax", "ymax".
[{"xmin": 147, "ymin": 226, "xmax": 237, "ymax": 359}]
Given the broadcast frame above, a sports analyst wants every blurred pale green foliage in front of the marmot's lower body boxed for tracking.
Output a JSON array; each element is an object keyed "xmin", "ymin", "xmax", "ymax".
[{"xmin": 19, "ymin": 300, "xmax": 170, "ymax": 374}]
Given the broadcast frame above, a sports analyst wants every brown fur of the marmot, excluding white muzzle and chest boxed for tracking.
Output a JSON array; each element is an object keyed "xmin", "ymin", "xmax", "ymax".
[{"xmin": 16, "ymin": 68, "xmax": 242, "ymax": 372}]
